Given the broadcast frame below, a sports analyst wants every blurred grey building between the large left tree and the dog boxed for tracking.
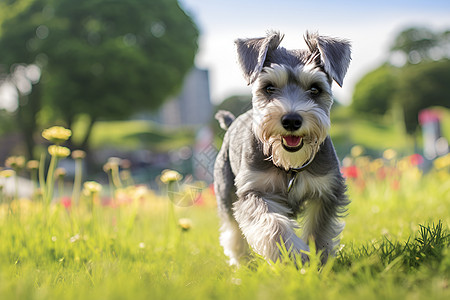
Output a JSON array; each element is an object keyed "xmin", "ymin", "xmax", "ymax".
[{"xmin": 156, "ymin": 67, "xmax": 213, "ymax": 127}]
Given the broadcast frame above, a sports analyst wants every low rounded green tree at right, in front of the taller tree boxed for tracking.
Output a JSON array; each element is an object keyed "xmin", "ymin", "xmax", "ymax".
[{"xmin": 351, "ymin": 59, "xmax": 450, "ymax": 134}]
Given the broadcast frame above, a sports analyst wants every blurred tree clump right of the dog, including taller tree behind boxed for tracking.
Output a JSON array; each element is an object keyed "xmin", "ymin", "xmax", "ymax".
[{"xmin": 351, "ymin": 28, "xmax": 450, "ymax": 134}]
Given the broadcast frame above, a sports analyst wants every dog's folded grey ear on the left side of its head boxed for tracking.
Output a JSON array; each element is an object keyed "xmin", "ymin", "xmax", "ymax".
[{"xmin": 235, "ymin": 32, "xmax": 283, "ymax": 85}]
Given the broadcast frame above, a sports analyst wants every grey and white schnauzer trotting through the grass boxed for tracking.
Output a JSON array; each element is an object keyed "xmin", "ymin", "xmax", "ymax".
[{"xmin": 214, "ymin": 32, "xmax": 351, "ymax": 265}]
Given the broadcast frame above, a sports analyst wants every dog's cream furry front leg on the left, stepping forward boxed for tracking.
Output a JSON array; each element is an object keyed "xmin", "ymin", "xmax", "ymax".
[{"xmin": 233, "ymin": 192, "xmax": 309, "ymax": 262}]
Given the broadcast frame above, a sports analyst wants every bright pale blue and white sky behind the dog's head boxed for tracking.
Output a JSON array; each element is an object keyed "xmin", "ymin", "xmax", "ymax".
[{"xmin": 180, "ymin": 0, "xmax": 450, "ymax": 103}]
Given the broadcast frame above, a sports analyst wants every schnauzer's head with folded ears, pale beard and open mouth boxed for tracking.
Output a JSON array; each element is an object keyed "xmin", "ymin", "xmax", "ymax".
[{"xmin": 236, "ymin": 32, "xmax": 351, "ymax": 170}]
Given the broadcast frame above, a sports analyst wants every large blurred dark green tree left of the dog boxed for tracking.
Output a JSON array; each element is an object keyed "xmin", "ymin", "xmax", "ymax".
[{"xmin": 0, "ymin": 0, "xmax": 198, "ymax": 158}]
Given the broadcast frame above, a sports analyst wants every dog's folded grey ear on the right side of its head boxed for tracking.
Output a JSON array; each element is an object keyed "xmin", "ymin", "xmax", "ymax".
[{"xmin": 305, "ymin": 32, "xmax": 351, "ymax": 87}]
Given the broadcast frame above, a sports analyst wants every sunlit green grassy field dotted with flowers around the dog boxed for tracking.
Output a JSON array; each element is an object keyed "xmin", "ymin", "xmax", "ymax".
[{"xmin": 0, "ymin": 152, "xmax": 450, "ymax": 299}]
